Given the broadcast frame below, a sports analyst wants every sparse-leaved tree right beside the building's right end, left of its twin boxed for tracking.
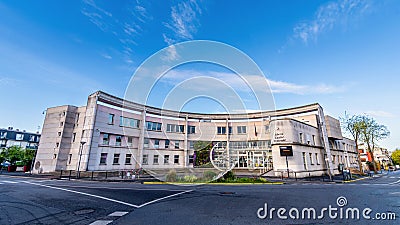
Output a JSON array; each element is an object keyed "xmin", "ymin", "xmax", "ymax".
[{"xmin": 340, "ymin": 114, "xmax": 362, "ymax": 172}]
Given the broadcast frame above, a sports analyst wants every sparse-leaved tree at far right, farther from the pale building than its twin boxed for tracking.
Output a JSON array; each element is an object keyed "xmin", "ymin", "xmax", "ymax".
[{"xmin": 361, "ymin": 116, "xmax": 390, "ymax": 173}]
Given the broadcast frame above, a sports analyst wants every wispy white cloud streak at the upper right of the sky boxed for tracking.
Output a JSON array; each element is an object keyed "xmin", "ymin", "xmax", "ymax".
[{"xmin": 293, "ymin": 0, "xmax": 371, "ymax": 43}]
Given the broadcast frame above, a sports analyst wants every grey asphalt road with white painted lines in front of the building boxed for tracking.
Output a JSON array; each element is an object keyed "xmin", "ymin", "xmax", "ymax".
[{"xmin": 0, "ymin": 171, "xmax": 400, "ymax": 224}]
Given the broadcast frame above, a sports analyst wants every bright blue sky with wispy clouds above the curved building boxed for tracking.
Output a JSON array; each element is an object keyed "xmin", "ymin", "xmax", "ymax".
[{"xmin": 0, "ymin": 0, "xmax": 400, "ymax": 149}]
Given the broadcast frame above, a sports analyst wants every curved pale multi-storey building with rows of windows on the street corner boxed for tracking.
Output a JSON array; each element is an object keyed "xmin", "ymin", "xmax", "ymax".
[{"xmin": 35, "ymin": 91, "xmax": 358, "ymax": 177}]
